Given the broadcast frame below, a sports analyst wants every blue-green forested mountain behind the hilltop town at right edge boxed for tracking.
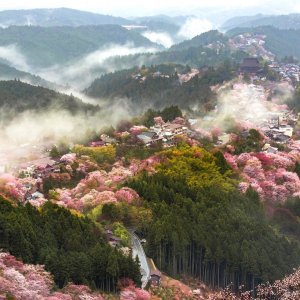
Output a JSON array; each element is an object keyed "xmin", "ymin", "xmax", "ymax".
[{"xmin": 227, "ymin": 26, "xmax": 300, "ymax": 58}]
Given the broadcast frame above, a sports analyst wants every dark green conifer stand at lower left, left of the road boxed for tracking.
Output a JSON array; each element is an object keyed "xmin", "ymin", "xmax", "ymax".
[{"xmin": 0, "ymin": 196, "xmax": 140, "ymax": 291}]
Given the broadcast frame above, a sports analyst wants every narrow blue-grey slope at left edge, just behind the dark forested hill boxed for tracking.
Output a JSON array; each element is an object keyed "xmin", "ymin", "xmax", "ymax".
[{"xmin": 0, "ymin": 63, "xmax": 58, "ymax": 89}]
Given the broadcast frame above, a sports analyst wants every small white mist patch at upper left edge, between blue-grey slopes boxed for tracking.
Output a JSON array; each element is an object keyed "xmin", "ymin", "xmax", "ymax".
[{"xmin": 0, "ymin": 44, "xmax": 29, "ymax": 71}]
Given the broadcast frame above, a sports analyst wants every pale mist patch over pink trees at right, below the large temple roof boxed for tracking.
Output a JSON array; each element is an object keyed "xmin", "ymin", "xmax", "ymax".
[{"xmin": 195, "ymin": 83, "xmax": 293, "ymax": 131}]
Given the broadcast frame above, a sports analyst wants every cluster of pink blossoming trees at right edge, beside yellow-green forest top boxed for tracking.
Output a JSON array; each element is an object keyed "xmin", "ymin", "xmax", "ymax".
[{"xmin": 224, "ymin": 150, "xmax": 300, "ymax": 202}]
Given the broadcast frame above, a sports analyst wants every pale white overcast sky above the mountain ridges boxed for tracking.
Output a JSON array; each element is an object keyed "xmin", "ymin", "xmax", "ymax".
[{"xmin": 0, "ymin": 0, "xmax": 300, "ymax": 17}]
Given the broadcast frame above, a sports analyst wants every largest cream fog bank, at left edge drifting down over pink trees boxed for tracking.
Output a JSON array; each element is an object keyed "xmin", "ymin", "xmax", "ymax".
[{"xmin": 0, "ymin": 99, "xmax": 134, "ymax": 169}]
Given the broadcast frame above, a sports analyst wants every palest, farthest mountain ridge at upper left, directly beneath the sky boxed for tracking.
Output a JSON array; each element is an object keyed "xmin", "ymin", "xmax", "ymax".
[{"xmin": 0, "ymin": 8, "xmax": 130, "ymax": 27}]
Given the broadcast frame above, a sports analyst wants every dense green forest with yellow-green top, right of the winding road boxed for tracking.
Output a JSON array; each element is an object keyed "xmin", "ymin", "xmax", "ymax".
[{"xmin": 127, "ymin": 147, "xmax": 300, "ymax": 289}]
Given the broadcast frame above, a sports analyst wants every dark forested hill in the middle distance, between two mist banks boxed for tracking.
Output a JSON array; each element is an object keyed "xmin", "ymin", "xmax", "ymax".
[{"xmin": 85, "ymin": 62, "xmax": 237, "ymax": 111}]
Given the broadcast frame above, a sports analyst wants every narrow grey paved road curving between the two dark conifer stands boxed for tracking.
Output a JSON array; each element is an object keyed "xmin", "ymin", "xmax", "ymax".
[{"xmin": 131, "ymin": 232, "xmax": 150, "ymax": 288}]
